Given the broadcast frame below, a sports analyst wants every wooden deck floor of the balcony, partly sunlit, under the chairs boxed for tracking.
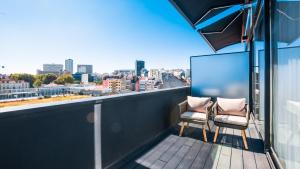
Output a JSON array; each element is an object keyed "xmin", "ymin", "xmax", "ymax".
[{"xmin": 122, "ymin": 121, "xmax": 271, "ymax": 169}]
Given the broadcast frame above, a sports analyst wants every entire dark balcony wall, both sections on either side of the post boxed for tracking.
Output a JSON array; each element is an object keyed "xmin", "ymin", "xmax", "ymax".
[{"xmin": 0, "ymin": 87, "xmax": 190, "ymax": 169}]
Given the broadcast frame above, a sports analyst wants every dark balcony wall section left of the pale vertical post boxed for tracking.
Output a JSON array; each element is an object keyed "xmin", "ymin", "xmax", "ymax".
[{"xmin": 0, "ymin": 99, "xmax": 94, "ymax": 169}]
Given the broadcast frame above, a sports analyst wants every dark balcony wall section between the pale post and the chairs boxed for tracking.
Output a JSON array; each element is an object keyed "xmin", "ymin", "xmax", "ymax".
[{"xmin": 101, "ymin": 88, "xmax": 189, "ymax": 166}]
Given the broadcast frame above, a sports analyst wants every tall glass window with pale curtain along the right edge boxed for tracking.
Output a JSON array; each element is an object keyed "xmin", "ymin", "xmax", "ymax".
[{"xmin": 272, "ymin": 0, "xmax": 300, "ymax": 169}]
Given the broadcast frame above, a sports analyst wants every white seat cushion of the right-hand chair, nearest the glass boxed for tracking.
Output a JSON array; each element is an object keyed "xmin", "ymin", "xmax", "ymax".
[{"xmin": 215, "ymin": 115, "xmax": 247, "ymax": 126}]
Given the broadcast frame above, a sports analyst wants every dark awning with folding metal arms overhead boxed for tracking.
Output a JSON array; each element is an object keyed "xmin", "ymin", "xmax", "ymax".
[{"xmin": 170, "ymin": 0, "xmax": 248, "ymax": 51}]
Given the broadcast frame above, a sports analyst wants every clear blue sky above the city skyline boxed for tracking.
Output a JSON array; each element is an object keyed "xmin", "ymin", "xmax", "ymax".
[{"xmin": 0, "ymin": 0, "xmax": 243, "ymax": 73}]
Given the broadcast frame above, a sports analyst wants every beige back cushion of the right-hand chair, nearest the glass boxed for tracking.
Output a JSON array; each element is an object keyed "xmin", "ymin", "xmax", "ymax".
[{"xmin": 217, "ymin": 97, "xmax": 247, "ymax": 117}]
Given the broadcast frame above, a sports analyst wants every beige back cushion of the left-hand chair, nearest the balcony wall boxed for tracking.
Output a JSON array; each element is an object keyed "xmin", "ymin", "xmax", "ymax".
[{"xmin": 187, "ymin": 96, "xmax": 210, "ymax": 112}]
